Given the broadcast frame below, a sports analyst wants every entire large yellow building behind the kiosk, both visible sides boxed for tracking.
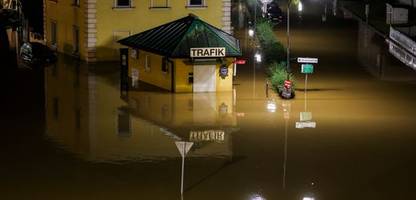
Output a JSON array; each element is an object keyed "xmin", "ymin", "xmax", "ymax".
[{"xmin": 44, "ymin": 0, "xmax": 231, "ymax": 62}]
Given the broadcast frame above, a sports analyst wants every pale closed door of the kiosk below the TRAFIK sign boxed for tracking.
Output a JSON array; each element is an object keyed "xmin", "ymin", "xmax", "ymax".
[{"xmin": 193, "ymin": 65, "xmax": 217, "ymax": 92}]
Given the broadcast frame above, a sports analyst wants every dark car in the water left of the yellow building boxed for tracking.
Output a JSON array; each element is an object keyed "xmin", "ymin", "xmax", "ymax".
[{"xmin": 20, "ymin": 42, "xmax": 57, "ymax": 66}]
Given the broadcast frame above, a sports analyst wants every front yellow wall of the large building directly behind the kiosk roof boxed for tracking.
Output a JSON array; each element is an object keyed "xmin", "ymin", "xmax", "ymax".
[{"xmin": 97, "ymin": 0, "xmax": 224, "ymax": 60}]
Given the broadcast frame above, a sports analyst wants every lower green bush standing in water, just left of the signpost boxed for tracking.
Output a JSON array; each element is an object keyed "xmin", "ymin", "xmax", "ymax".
[{"xmin": 268, "ymin": 62, "xmax": 295, "ymax": 94}]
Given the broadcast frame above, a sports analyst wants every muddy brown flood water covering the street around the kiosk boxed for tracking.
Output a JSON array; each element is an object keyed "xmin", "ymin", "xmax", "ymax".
[{"xmin": 0, "ymin": 1, "xmax": 416, "ymax": 200}]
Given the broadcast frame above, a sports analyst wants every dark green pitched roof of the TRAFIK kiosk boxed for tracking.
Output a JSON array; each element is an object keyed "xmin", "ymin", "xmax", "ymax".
[{"xmin": 118, "ymin": 14, "xmax": 241, "ymax": 58}]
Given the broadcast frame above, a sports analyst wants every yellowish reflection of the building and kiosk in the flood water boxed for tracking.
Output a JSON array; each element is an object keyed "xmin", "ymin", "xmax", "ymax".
[{"xmin": 45, "ymin": 59, "xmax": 237, "ymax": 162}]
